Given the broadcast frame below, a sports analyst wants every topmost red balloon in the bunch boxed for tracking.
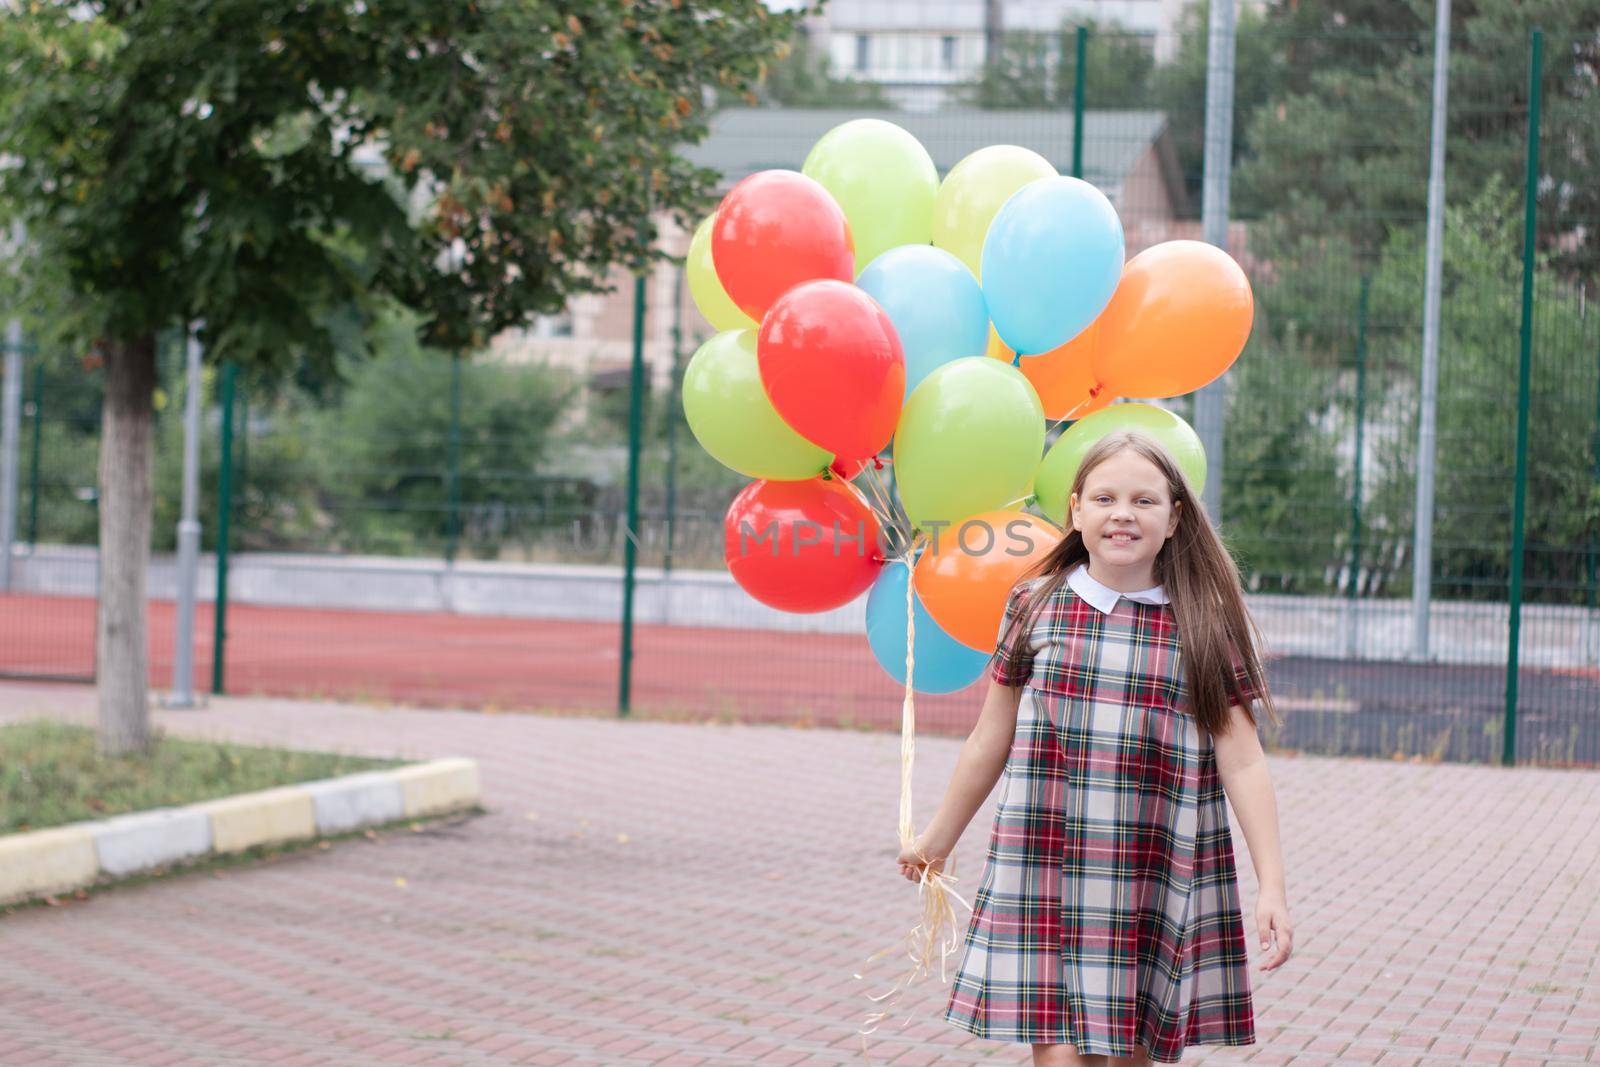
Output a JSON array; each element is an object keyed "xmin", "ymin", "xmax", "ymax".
[{"xmin": 710, "ymin": 170, "xmax": 856, "ymax": 322}]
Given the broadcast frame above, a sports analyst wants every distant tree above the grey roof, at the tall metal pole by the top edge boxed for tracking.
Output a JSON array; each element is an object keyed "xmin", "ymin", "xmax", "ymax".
[{"xmin": 962, "ymin": 19, "xmax": 1155, "ymax": 109}]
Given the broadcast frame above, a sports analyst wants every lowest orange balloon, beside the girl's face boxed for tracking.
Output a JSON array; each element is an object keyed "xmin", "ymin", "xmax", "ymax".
[{"xmin": 912, "ymin": 509, "xmax": 1062, "ymax": 653}]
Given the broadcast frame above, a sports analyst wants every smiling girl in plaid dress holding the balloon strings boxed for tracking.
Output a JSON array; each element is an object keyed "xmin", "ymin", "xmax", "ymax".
[{"xmin": 899, "ymin": 434, "xmax": 1293, "ymax": 1067}]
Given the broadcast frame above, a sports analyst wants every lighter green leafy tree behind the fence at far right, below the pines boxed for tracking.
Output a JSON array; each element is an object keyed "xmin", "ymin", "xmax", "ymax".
[{"xmin": 1371, "ymin": 179, "xmax": 1600, "ymax": 603}]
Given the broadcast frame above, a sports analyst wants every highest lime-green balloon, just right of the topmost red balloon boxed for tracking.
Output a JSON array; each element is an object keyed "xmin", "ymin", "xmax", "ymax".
[{"xmin": 800, "ymin": 118, "xmax": 939, "ymax": 274}]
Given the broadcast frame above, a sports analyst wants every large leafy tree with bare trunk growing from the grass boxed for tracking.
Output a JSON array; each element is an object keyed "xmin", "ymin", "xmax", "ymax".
[{"xmin": 0, "ymin": 0, "xmax": 800, "ymax": 753}]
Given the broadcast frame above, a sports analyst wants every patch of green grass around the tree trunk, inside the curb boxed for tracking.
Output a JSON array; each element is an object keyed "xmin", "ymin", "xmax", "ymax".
[{"xmin": 0, "ymin": 720, "xmax": 403, "ymax": 833}]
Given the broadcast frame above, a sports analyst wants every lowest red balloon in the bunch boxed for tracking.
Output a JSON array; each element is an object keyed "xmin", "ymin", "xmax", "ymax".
[{"xmin": 723, "ymin": 478, "xmax": 883, "ymax": 613}]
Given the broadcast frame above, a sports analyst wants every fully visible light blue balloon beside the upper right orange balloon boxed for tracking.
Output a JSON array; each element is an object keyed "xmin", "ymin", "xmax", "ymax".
[{"xmin": 982, "ymin": 178, "xmax": 1125, "ymax": 355}]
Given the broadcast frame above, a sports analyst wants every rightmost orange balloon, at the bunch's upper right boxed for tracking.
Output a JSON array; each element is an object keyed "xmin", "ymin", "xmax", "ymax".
[{"xmin": 1091, "ymin": 242, "xmax": 1254, "ymax": 398}]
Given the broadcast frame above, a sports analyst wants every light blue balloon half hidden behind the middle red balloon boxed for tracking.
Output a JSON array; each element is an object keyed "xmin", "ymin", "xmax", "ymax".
[{"xmin": 856, "ymin": 245, "xmax": 989, "ymax": 397}]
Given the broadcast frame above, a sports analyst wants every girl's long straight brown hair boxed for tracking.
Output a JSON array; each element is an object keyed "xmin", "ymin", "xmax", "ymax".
[{"xmin": 1006, "ymin": 430, "xmax": 1282, "ymax": 736}]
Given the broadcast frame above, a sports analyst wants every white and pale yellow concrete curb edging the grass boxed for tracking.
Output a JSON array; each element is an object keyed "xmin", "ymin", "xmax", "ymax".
[{"xmin": 0, "ymin": 758, "xmax": 478, "ymax": 904}]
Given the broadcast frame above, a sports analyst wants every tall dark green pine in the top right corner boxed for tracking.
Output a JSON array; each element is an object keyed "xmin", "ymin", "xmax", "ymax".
[{"xmin": 1235, "ymin": 0, "xmax": 1600, "ymax": 277}]
